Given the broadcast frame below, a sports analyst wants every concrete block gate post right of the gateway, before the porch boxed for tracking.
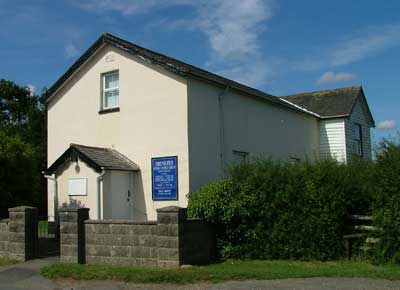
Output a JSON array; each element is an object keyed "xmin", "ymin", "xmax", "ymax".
[{"xmin": 59, "ymin": 208, "xmax": 89, "ymax": 264}]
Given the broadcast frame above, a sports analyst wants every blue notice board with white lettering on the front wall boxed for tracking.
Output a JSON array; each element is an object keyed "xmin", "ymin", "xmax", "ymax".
[{"xmin": 151, "ymin": 156, "xmax": 178, "ymax": 200}]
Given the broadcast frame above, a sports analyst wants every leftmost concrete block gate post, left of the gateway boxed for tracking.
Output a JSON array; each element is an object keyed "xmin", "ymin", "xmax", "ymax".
[{"xmin": 8, "ymin": 206, "xmax": 38, "ymax": 261}]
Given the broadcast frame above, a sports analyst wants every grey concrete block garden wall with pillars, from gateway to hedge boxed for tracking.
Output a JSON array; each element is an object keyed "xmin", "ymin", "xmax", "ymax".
[{"xmin": 60, "ymin": 206, "xmax": 214, "ymax": 267}]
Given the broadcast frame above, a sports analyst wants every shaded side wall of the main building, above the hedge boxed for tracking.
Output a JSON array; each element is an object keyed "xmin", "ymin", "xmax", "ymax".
[{"xmin": 188, "ymin": 78, "xmax": 319, "ymax": 190}]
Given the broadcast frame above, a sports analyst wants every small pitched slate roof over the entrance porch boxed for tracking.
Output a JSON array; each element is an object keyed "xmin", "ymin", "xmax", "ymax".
[{"xmin": 45, "ymin": 144, "xmax": 139, "ymax": 175}]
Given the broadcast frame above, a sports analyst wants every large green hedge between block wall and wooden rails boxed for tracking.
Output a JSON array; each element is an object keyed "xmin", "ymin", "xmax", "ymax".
[{"xmin": 189, "ymin": 160, "xmax": 374, "ymax": 260}]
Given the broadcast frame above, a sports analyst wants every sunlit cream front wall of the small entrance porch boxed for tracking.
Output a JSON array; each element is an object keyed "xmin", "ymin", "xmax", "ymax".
[{"xmin": 54, "ymin": 160, "xmax": 98, "ymax": 219}]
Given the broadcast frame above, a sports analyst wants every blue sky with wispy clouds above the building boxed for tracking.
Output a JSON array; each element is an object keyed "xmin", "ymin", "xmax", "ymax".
[{"xmin": 0, "ymin": 0, "xmax": 400, "ymax": 141}]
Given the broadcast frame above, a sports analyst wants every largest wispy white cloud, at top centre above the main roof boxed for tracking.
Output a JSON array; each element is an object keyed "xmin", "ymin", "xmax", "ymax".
[{"xmin": 192, "ymin": 0, "xmax": 272, "ymax": 86}]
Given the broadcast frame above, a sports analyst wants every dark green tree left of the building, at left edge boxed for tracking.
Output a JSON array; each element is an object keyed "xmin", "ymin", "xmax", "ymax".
[{"xmin": 0, "ymin": 79, "xmax": 46, "ymax": 217}]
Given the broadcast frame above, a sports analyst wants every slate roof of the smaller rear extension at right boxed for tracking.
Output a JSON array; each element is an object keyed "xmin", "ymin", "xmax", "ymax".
[{"xmin": 281, "ymin": 86, "xmax": 373, "ymax": 120}]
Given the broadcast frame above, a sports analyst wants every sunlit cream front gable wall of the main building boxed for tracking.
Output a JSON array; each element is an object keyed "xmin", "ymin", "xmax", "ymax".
[{"xmin": 48, "ymin": 46, "xmax": 189, "ymax": 220}]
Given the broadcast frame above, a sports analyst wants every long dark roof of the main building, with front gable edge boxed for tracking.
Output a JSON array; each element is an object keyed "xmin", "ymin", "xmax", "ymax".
[{"xmin": 46, "ymin": 33, "xmax": 316, "ymax": 114}]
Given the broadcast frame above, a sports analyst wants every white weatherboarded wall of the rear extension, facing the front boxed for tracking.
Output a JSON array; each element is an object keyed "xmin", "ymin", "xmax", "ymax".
[{"xmin": 319, "ymin": 118, "xmax": 346, "ymax": 162}]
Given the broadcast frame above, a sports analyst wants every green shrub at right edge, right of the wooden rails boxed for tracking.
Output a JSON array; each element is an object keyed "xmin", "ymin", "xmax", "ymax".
[{"xmin": 374, "ymin": 140, "xmax": 400, "ymax": 263}]
